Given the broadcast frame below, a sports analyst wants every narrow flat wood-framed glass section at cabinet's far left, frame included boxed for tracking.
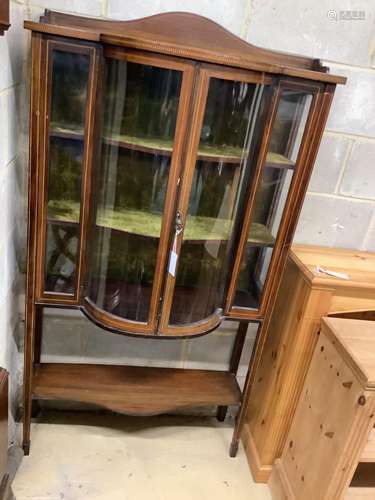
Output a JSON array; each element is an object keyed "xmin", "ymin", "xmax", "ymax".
[{"xmin": 36, "ymin": 39, "xmax": 101, "ymax": 303}]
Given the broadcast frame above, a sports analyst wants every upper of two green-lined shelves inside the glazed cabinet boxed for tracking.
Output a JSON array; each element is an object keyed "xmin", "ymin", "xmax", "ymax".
[{"xmin": 51, "ymin": 126, "xmax": 294, "ymax": 169}]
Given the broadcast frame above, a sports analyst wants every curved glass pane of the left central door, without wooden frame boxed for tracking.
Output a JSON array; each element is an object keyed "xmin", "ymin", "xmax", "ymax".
[{"xmin": 89, "ymin": 59, "xmax": 182, "ymax": 322}]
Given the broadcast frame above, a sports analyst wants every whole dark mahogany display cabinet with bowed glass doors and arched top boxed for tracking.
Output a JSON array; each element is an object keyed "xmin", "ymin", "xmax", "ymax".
[{"xmin": 24, "ymin": 11, "xmax": 345, "ymax": 454}]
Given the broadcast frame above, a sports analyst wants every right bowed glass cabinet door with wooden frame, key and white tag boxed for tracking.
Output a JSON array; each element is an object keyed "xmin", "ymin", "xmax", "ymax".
[{"xmin": 160, "ymin": 65, "xmax": 275, "ymax": 335}]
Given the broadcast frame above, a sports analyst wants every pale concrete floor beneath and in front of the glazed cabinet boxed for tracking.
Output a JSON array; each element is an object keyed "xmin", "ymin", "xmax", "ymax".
[{"xmin": 13, "ymin": 412, "xmax": 271, "ymax": 500}]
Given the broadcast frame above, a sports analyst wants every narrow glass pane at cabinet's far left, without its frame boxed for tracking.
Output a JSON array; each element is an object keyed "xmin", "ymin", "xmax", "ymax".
[{"xmin": 45, "ymin": 50, "xmax": 90, "ymax": 294}]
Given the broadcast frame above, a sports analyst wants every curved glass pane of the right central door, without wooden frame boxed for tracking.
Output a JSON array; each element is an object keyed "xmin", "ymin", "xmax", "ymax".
[{"xmin": 170, "ymin": 78, "xmax": 270, "ymax": 325}]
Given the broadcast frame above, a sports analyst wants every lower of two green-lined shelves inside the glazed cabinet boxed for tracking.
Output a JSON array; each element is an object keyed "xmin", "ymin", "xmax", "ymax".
[{"xmin": 48, "ymin": 200, "xmax": 275, "ymax": 246}]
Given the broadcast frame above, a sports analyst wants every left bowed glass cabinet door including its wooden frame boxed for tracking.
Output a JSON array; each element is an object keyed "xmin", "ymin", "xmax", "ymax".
[{"xmin": 84, "ymin": 48, "xmax": 194, "ymax": 334}]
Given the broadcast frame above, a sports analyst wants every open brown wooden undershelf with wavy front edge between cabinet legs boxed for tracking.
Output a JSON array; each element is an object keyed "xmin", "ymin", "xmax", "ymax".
[{"xmin": 33, "ymin": 363, "xmax": 241, "ymax": 415}]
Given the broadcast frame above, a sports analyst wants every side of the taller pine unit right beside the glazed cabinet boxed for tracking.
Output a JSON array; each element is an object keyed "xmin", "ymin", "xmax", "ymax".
[{"xmin": 247, "ymin": 260, "xmax": 330, "ymax": 475}]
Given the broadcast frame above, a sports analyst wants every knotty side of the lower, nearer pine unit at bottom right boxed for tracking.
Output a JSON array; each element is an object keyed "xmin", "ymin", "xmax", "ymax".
[{"xmin": 270, "ymin": 326, "xmax": 374, "ymax": 500}]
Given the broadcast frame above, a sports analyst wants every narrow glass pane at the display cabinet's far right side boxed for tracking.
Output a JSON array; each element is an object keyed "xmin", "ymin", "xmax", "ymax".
[{"xmin": 234, "ymin": 89, "xmax": 313, "ymax": 309}]
